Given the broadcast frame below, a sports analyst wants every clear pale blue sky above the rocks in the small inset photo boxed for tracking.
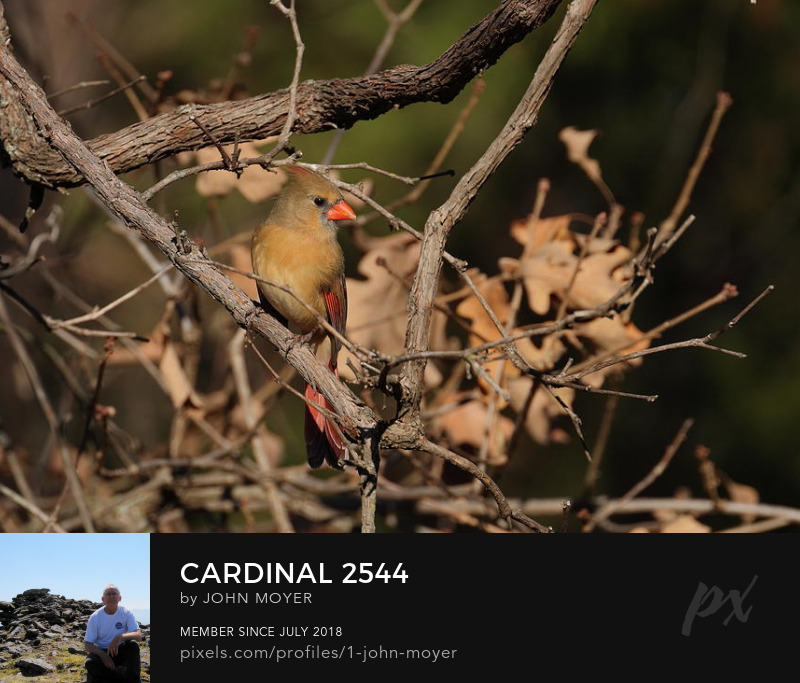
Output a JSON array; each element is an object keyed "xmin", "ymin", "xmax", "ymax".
[{"xmin": 0, "ymin": 534, "xmax": 150, "ymax": 609}]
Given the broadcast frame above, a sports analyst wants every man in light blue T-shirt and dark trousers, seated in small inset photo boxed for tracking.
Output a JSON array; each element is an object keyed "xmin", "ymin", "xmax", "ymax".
[{"xmin": 83, "ymin": 583, "xmax": 142, "ymax": 683}]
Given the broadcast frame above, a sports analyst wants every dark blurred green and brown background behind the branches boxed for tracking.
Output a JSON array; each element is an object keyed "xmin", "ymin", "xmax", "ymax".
[{"xmin": 0, "ymin": 0, "xmax": 800, "ymax": 505}]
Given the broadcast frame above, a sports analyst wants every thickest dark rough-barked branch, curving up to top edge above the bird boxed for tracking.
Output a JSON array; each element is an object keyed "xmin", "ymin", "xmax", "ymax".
[{"xmin": 0, "ymin": 0, "xmax": 561, "ymax": 188}]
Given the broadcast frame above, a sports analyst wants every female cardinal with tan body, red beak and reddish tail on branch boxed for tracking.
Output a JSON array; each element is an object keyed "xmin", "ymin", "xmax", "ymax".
[{"xmin": 251, "ymin": 166, "xmax": 356, "ymax": 469}]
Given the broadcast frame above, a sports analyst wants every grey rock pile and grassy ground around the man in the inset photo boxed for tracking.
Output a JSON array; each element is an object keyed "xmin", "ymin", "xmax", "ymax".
[{"xmin": 0, "ymin": 588, "xmax": 150, "ymax": 683}]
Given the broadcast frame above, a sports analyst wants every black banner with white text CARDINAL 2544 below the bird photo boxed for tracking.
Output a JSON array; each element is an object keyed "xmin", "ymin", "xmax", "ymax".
[{"xmin": 151, "ymin": 534, "xmax": 800, "ymax": 681}]
